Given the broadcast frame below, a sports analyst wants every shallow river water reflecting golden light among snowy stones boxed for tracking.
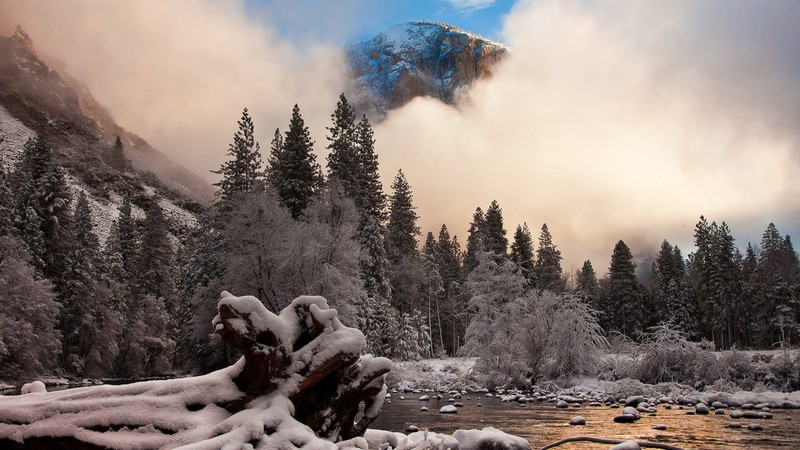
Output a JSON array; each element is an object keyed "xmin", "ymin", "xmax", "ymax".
[{"xmin": 370, "ymin": 394, "xmax": 800, "ymax": 450}]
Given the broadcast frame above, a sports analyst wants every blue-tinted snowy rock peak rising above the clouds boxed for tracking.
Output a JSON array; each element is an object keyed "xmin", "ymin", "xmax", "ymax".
[{"xmin": 347, "ymin": 21, "xmax": 509, "ymax": 115}]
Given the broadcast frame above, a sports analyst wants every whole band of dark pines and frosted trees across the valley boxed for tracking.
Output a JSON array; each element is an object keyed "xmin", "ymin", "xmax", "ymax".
[{"xmin": 0, "ymin": 95, "xmax": 800, "ymax": 380}]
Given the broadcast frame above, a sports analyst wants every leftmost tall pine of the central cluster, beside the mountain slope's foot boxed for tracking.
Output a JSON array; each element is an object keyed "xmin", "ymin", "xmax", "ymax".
[{"xmin": 211, "ymin": 108, "xmax": 262, "ymax": 202}]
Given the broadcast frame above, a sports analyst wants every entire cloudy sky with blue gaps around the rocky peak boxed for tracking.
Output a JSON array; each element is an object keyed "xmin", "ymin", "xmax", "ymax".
[{"xmin": 0, "ymin": 0, "xmax": 800, "ymax": 273}]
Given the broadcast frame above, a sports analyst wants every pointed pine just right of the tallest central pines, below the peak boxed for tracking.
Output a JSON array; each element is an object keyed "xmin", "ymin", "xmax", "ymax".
[{"xmin": 385, "ymin": 170, "xmax": 421, "ymax": 264}]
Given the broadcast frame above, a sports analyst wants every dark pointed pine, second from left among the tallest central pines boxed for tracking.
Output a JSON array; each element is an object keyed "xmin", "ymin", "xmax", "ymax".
[{"xmin": 267, "ymin": 104, "xmax": 322, "ymax": 219}]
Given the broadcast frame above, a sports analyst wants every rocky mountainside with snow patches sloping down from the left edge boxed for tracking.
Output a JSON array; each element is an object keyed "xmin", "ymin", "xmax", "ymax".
[{"xmin": 0, "ymin": 27, "xmax": 214, "ymax": 240}]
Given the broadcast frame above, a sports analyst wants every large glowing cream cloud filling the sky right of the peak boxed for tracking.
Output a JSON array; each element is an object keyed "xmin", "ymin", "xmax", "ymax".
[{"xmin": 376, "ymin": 1, "xmax": 800, "ymax": 272}]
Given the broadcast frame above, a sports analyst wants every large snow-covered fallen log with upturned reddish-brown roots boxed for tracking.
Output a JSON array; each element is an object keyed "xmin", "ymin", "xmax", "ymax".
[{"xmin": 0, "ymin": 292, "xmax": 391, "ymax": 449}]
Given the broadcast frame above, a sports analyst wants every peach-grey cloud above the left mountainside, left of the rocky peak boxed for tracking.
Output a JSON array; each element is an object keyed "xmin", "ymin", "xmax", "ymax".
[{"xmin": 0, "ymin": 0, "xmax": 345, "ymax": 183}]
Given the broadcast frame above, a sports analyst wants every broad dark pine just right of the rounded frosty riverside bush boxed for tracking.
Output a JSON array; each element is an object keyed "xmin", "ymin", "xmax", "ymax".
[{"xmin": 601, "ymin": 240, "xmax": 644, "ymax": 336}]
